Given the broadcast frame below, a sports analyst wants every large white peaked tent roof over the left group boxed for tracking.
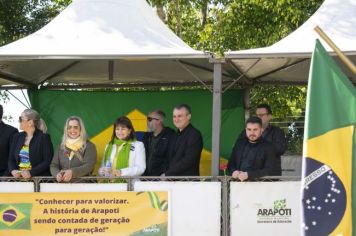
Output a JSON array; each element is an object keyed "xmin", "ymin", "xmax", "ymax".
[{"xmin": 0, "ymin": 0, "xmax": 221, "ymax": 86}]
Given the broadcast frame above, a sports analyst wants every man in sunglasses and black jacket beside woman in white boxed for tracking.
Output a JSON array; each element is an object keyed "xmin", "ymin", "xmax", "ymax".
[{"xmin": 142, "ymin": 110, "xmax": 174, "ymax": 176}]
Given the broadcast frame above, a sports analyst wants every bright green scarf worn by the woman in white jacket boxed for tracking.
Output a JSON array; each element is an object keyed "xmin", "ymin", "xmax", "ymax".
[{"xmin": 104, "ymin": 138, "xmax": 135, "ymax": 170}]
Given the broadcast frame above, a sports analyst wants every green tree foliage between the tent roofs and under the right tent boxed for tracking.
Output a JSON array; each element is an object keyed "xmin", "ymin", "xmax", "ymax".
[{"xmin": 149, "ymin": 0, "xmax": 323, "ymax": 119}]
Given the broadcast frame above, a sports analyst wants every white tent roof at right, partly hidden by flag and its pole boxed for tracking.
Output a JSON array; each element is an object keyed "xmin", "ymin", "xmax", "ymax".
[{"xmin": 225, "ymin": 0, "xmax": 356, "ymax": 84}]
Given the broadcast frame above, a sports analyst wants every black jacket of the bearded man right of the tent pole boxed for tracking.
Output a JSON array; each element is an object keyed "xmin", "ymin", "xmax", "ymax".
[{"xmin": 228, "ymin": 138, "xmax": 277, "ymax": 179}]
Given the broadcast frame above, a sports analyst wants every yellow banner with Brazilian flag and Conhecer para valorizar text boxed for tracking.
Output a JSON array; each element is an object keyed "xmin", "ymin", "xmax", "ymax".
[{"xmin": 0, "ymin": 191, "xmax": 169, "ymax": 236}]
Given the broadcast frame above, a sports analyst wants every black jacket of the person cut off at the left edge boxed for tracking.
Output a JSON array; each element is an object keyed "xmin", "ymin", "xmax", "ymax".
[{"xmin": 0, "ymin": 121, "xmax": 18, "ymax": 176}]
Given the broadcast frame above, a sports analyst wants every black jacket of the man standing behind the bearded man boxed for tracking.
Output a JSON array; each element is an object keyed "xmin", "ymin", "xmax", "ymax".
[{"xmin": 239, "ymin": 125, "xmax": 287, "ymax": 176}]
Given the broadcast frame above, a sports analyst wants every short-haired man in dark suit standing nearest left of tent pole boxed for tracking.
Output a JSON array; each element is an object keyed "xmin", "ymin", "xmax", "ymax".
[{"xmin": 163, "ymin": 104, "xmax": 203, "ymax": 176}]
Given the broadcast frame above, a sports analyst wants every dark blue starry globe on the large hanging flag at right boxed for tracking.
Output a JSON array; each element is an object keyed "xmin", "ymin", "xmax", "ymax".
[{"xmin": 302, "ymin": 157, "xmax": 346, "ymax": 236}]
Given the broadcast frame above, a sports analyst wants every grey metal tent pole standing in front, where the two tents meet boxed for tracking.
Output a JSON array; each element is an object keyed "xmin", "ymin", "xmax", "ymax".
[{"xmin": 210, "ymin": 59, "xmax": 224, "ymax": 177}]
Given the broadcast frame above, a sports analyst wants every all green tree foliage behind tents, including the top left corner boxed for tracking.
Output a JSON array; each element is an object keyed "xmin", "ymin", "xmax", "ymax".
[{"xmin": 0, "ymin": 0, "xmax": 323, "ymax": 122}]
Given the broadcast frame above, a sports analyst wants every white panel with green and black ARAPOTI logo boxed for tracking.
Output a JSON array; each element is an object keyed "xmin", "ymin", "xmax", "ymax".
[{"xmin": 230, "ymin": 181, "xmax": 301, "ymax": 236}]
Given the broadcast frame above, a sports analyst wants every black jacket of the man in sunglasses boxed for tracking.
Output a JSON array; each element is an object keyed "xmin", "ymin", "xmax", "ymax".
[{"xmin": 142, "ymin": 127, "xmax": 174, "ymax": 176}]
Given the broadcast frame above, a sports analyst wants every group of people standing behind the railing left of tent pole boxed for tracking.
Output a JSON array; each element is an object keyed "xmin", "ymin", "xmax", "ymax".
[{"xmin": 0, "ymin": 104, "xmax": 203, "ymax": 182}]
